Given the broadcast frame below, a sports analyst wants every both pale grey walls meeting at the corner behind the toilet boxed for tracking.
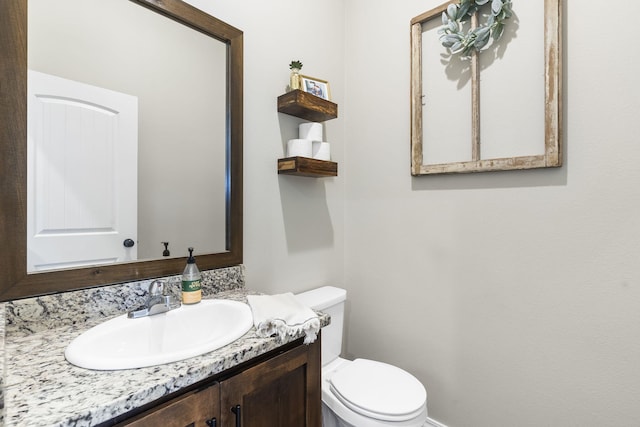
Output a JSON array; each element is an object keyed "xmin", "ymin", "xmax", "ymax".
[{"xmin": 176, "ymin": 0, "xmax": 640, "ymax": 427}]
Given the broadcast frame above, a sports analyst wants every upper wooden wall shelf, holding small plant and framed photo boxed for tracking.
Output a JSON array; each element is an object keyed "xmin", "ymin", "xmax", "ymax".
[{"xmin": 278, "ymin": 89, "xmax": 338, "ymax": 122}]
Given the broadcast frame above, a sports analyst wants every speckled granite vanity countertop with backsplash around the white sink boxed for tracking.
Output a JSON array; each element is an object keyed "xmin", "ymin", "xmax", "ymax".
[{"xmin": 4, "ymin": 269, "xmax": 328, "ymax": 427}]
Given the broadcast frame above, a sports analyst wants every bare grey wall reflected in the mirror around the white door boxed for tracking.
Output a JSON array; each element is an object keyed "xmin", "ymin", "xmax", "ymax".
[{"xmin": 28, "ymin": 0, "xmax": 227, "ymax": 270}]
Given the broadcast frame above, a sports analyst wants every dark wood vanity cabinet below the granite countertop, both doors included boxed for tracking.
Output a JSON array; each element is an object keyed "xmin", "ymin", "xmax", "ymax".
[{"xmin": 117, "ymin": 337, "xmax": 322, "ymax": 427}]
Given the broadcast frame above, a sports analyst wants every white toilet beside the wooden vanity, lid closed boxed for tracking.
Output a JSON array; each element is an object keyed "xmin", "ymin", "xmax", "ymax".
[{"xmin": 296, "ymin": 286, "xmax": 427, "ymax": 427}]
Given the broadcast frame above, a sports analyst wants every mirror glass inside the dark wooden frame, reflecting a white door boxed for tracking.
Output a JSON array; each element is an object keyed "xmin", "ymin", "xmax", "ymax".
[{"xmin": 27, "ymin": 0, "xmax": 227, "ymax": 273}]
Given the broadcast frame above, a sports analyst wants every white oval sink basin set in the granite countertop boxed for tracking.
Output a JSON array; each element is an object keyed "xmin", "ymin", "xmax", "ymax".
[{"xmin": 64, "ymin": 299, "xmax": 253, "ymax": 370}]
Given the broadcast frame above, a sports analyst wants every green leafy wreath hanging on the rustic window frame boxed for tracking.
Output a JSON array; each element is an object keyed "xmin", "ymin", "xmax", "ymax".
[{"xmin": 438, "ymin": 0, "xmax": 513, "ymax": 57}]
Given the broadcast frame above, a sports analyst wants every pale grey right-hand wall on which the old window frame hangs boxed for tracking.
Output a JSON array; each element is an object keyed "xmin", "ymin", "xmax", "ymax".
[{"xmin": 344, "ymin": 0, "xmax": 640, "ymax": 427}]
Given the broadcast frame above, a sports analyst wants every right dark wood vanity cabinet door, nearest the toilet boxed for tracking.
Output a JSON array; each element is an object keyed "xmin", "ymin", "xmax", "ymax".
[{"xmin": 220, "ymin": 337, "xmax": 321, "ymax": 427}]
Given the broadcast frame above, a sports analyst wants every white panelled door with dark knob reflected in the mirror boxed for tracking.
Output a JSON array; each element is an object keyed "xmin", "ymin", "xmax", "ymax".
[{"xmin": 27, "ymin": 70, "xmax": 138, "ymax": 272}]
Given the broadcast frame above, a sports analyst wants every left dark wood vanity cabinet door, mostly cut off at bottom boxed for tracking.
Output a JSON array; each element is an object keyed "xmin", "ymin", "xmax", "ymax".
[{"xmin": 118, "ymin": 383, "xmax": 220, "ymax": 427}]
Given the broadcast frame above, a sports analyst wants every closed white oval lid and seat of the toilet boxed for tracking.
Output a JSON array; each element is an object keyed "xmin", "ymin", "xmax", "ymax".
[{"xmin": 329, "ymin": 359, "xmax": 427, "ymax": 421}]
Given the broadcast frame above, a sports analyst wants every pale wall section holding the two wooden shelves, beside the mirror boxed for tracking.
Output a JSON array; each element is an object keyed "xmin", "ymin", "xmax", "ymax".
[{"xmin": 189, "ymin": 0, "xmax": 346, "ymax": 293}]
